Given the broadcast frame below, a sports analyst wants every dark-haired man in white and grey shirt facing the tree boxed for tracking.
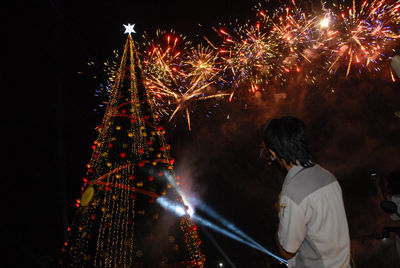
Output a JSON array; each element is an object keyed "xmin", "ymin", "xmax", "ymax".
[{"xmin": 263, "ymin": 116, "xmax": 350, "ymax": 268}]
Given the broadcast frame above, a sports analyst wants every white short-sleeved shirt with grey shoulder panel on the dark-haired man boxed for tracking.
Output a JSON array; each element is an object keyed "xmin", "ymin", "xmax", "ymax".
[{"xmin": 279, "ymin": 165, "xmax": 350, "ymax": 267}]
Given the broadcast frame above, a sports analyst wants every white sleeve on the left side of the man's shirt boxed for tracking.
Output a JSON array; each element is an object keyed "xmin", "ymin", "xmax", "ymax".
[{"xmin": 278, "ymin": 195, "xmax": 306, "ymax": 253}]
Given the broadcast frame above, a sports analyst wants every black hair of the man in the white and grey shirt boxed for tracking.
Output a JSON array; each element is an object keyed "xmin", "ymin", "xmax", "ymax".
[{"xmin": 263, "ymin": 116, "xmax": 314, "ymax": 167}]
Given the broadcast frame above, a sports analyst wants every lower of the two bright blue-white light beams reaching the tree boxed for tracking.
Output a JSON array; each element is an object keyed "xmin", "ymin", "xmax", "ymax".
[{"xmin": 156, "ymin": 196, "xmax": 287, "ymax": 265}]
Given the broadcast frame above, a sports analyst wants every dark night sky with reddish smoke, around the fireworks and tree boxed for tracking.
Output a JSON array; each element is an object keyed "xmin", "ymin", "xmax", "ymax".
[{"xmin": 4, "ymin": 0, "xmax": 400, "ymax": 267}]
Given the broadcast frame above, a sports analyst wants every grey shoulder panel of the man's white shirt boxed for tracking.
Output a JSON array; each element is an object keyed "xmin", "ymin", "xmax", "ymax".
[{"xmin": 282, "ymin": 164, "xmax": 336, "ymax": 204}]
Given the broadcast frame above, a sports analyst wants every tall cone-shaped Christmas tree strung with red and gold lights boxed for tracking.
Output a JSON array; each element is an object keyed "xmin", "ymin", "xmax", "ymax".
[{"xmin": 61, "ymin": 29, "xmax": 204, "ymax": 267}]
